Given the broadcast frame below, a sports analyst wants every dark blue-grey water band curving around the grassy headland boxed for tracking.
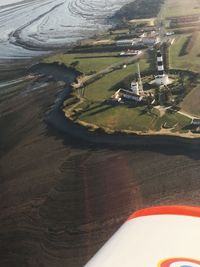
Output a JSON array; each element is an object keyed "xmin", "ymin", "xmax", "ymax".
[{"xmin": 30, "ymin": 64, "xmax": 200, "ymax": 150}]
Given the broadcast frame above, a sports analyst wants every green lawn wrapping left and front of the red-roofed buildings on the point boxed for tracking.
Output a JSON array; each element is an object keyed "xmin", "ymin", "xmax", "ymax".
[{"xmin": 69, "ymin": 55, "xmax": 190, "ymax": 132}]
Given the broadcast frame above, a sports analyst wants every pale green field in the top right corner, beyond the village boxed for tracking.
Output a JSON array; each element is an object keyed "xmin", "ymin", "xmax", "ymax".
[{"xmin": 165, "ymin": 0, "xmax": 200, "ymax": 17}]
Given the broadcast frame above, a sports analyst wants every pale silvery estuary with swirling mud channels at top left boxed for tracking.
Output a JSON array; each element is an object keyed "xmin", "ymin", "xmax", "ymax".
[{"xmin": 0, "ymin": 0, "xmax": 131, "ymax": 59}]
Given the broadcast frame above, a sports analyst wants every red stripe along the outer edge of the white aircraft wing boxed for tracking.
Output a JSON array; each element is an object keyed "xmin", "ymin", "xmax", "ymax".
[{"xmin": 128, "ymin": 206, "xmax": 200, "ymax": 220}]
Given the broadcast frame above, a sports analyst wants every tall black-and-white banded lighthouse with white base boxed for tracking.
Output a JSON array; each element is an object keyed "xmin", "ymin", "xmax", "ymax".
[{"xmin": 155, "ymin": 50, "xmax": 169, "ymax": 85}]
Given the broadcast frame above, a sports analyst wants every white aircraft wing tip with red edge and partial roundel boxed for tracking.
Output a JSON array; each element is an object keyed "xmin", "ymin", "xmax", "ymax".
[{"xmin": 85, "ymin": 206, "xmax": 200, "ymax": 267}]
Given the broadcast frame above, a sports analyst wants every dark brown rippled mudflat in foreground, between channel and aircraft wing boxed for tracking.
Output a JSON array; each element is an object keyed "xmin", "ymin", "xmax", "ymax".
[{"xmin": 0, "ymin": 61, "xmax": 200, "ymax": 267}]
